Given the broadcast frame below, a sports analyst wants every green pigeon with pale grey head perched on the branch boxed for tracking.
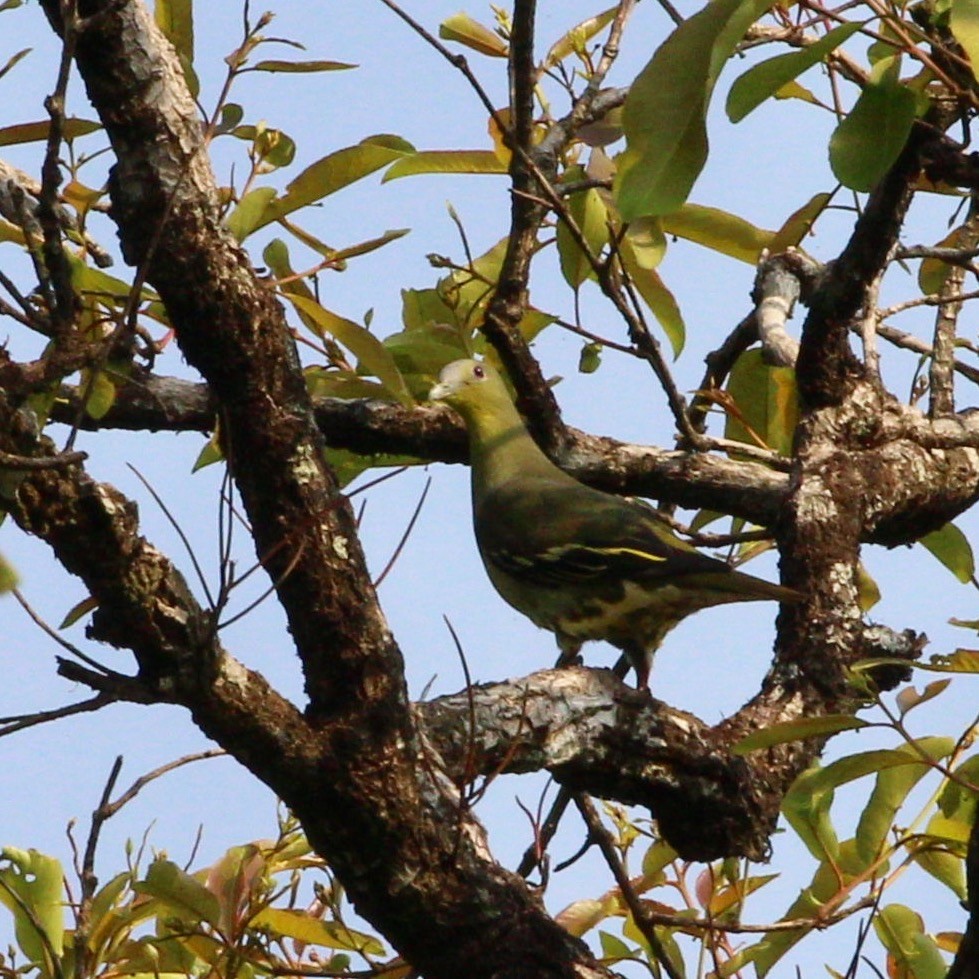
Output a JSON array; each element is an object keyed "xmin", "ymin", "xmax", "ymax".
[{"xmin": 429, "ymin": 360, "xmax": 801, "ymax": 690}]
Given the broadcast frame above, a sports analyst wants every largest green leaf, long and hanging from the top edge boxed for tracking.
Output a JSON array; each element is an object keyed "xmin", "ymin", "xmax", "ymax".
[{"xmin": 615, "ymin": 0, "xmax": 771, "ymax": 221}]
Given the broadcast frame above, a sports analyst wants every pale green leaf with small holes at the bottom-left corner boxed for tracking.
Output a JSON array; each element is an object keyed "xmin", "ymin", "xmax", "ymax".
[{"xmin": 0, "ymin": 846, "xmax": 64, "ymax": 964}]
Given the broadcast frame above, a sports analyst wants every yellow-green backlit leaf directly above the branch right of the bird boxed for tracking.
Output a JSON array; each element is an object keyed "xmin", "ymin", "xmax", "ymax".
[{"xmin": 724, "ymin": 349, "xmax": 799, "ymax": 456}]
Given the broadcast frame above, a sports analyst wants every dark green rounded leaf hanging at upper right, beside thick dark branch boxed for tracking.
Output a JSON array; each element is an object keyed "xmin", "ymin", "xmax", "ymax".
[{"xmin": 829, "ymin": 58, "xmax": 918, "ymax": 191}]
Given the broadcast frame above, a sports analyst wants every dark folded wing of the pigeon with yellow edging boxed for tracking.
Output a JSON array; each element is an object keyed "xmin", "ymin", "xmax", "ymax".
[{"xmin": 476, "ymin": 479, "xmax": 730, "ymax": 585}]
